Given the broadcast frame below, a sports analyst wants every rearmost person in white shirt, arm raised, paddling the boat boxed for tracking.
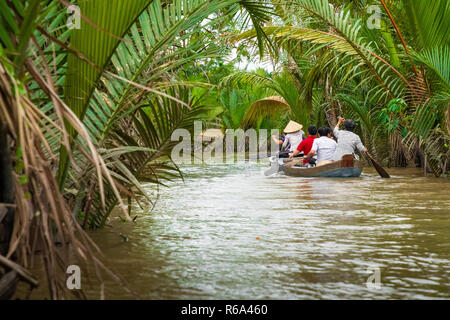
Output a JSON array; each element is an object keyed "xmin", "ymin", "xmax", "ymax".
[{"xmin": 333, "ymin": 117, "xmax": 367, "ymax": 161}]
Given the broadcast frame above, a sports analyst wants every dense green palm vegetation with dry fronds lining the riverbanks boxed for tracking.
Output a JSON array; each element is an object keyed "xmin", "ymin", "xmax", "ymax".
[{"xmin": 0, "ymin": 0, "xmax": 450, "ymax": 299}]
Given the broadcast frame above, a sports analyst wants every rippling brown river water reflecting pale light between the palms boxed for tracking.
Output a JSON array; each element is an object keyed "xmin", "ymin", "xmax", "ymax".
[{"xmin": 22, "ymin": 162, "xmax": 450, "ymax": 299}]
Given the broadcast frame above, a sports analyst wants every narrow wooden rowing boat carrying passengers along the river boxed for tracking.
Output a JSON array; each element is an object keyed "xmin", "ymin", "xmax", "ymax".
[{"xmin": 270, "ymin": 155, "xmax": 363, "ymax": 178}]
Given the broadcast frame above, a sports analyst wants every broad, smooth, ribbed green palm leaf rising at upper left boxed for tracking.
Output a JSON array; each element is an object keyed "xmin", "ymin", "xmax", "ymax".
[{"xmin": 65, "ymin": 0, "xmax": 152, "ymax": 119}]
